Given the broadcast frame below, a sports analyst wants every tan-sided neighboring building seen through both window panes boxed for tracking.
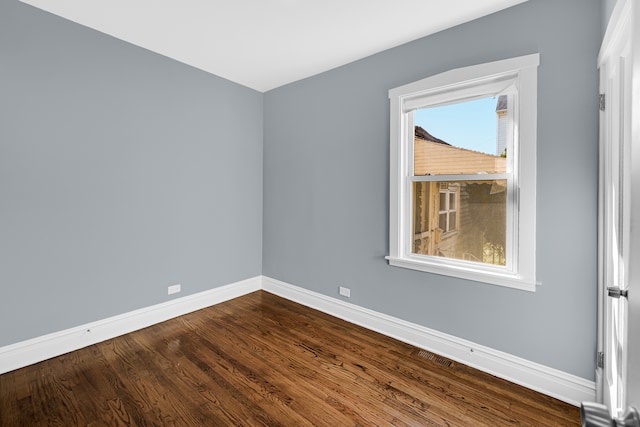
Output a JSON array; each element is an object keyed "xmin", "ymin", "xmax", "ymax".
[{"xmin": 413, "ymin": 126, "xmax": 507, "ymax": 264}]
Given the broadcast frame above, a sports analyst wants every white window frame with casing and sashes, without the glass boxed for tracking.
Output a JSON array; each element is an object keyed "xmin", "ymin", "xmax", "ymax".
[{"xmin": 386, "ymin": 54, "xmax": 540, "ymax": 291}]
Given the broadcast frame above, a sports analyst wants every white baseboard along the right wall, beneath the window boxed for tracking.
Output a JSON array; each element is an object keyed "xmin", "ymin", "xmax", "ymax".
[{"xmin": 262, "ymin": 277, "xmax": 596, "ymax": 406}]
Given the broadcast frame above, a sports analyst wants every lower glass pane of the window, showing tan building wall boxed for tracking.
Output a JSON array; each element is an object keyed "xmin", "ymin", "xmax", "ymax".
[{"xmin": 412, "ymin": 180, "xmax": 507, "ymax": 265}]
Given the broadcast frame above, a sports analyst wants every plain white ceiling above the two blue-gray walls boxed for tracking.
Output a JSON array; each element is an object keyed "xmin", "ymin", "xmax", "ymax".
[{"xmin": 21, "ymin": 0, "xmax": 526, "ymax": 92}]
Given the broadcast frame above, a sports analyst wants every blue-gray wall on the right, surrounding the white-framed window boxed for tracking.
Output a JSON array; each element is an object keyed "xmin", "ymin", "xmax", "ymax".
[{"xmin": 263, "ymin": 0, "xmax": 602, "ymax": 379}]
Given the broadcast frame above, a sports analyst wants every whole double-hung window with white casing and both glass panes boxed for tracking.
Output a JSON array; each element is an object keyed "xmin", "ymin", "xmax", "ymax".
[{"xmin": 387, "ymin": 54, "xmax": 539, "ymax": 291}]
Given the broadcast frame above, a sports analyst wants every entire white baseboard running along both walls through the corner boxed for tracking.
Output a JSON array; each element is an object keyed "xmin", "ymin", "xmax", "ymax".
[{"xmin": 0, "ymin": 276, "xmax": 596, "ymax": 406}]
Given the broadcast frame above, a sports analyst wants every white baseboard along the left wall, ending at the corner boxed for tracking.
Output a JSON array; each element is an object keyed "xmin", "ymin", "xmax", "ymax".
[{"xmin": 0, "ymin": 276, "xmax": 262, "ymax": 374}]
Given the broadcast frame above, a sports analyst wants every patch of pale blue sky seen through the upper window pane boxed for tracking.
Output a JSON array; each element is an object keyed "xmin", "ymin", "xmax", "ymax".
[{"xmin": 415, "ymin": 97, "xmax": 498, "ymax": 154}]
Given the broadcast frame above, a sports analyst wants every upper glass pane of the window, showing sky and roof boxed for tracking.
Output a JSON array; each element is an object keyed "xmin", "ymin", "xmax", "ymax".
[{"xmin": 414, "ymin": 95, "xmax": 509, "ymax": 176}]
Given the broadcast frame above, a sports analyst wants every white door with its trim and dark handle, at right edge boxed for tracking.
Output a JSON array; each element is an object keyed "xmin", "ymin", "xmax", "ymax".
[{"xmin": 597, "ymin": 0, "xmax": 640, "ymax": 417}]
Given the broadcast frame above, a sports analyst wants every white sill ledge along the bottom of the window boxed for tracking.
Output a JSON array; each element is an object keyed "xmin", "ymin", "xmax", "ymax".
[{"xmin": 385, "ymin": 256, "xmax": 539, "ymax": 292}]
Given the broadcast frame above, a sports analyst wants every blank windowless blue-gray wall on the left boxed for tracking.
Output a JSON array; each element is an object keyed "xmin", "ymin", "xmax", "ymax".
[{"xmin": 0, "ymin": 0, "xmax": 263, "ymax": 346}]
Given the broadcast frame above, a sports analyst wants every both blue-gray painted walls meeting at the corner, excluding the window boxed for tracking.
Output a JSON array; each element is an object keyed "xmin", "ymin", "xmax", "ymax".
[{"xmin": 0, "ymin": 0, "xmax": 610, "ymax": 379}]
